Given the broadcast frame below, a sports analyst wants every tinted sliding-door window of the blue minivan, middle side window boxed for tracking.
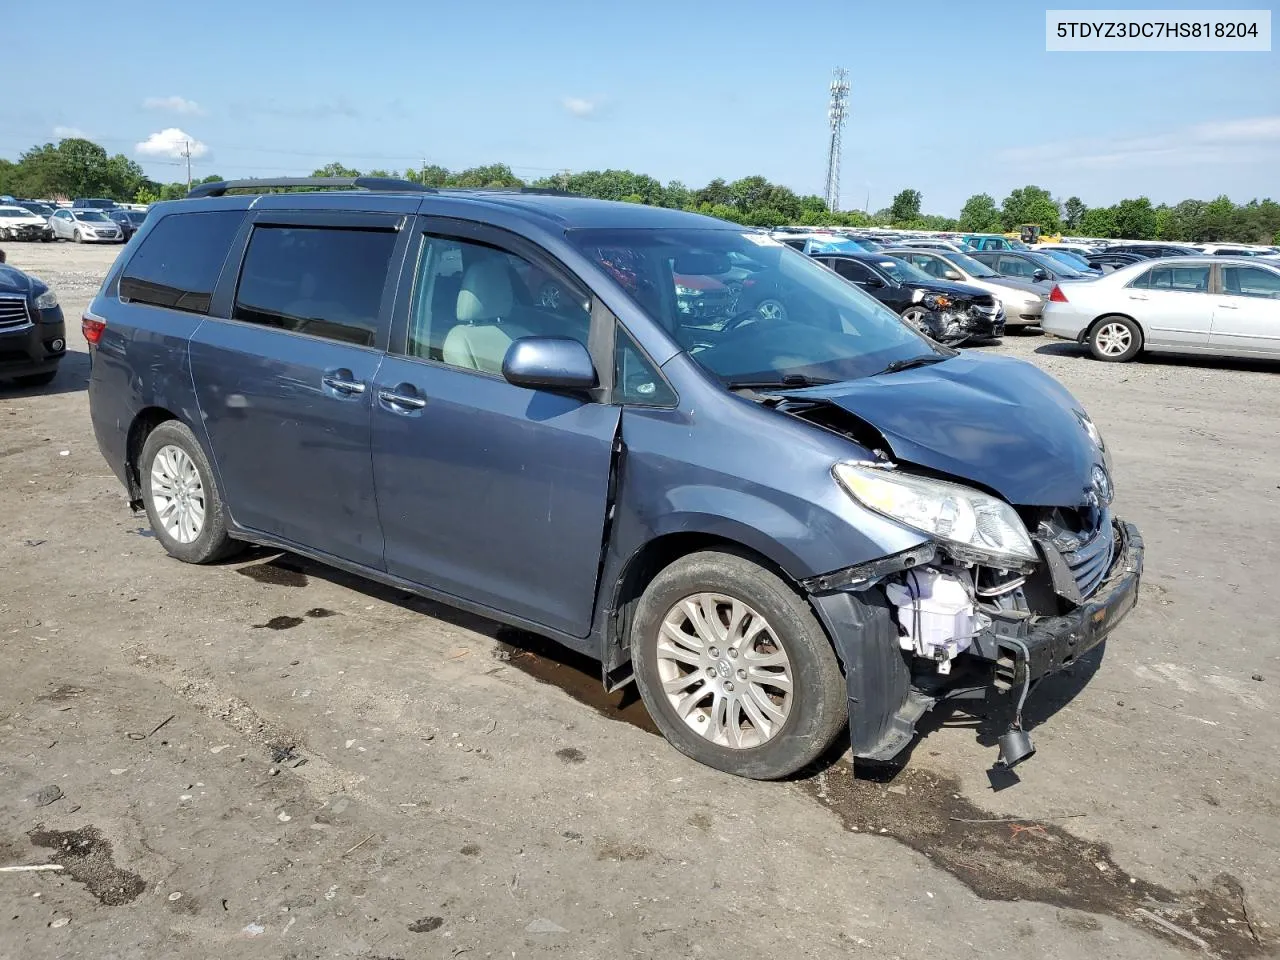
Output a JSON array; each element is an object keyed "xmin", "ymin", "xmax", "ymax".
[{"xmin": 232, "ymin": 225, "xmax": 396, "ymax": 347}]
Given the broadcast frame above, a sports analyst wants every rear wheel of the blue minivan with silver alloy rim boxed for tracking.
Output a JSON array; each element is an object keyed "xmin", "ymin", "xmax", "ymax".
[{"xmin": 138, "ymin": 420, "xmax": 239, "ymax": 563}]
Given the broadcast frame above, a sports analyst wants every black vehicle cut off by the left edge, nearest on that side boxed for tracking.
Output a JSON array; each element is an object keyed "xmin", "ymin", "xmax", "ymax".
[{"xmin": 0, "ymin": 257, "xmax": 67, "ymax": 387}]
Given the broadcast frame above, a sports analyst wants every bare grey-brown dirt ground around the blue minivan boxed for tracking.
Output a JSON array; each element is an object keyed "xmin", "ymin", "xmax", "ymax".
[{"xmin": 0, "ymin": 243, "xmax": 1280, "ymax": 960}]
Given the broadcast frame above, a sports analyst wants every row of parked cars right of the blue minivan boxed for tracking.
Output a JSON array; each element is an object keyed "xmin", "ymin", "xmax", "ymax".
[{"xmin": 752, "ymin": 230, "xmax": 1280, "ymax": 361}]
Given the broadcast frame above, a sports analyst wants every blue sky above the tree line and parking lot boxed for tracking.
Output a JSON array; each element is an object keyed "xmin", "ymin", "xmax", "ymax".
[{"xmin": 0, "ymin": 0, "xmax": 1280, "ymax": 215}]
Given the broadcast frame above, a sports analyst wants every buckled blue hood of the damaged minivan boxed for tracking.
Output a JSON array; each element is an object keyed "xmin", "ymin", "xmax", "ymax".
[{"xmin": 791, "ymin": 353, "xmax": 1103, "ymax": 507}]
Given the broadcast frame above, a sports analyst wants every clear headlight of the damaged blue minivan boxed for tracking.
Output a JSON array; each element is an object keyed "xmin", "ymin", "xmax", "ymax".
[{"xmin": 832, "ymin": 463, "xmax": 1037, "ymax": 566}]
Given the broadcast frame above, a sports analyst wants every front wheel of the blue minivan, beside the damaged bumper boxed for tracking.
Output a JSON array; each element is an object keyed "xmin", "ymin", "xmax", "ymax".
[{"xmin": 631, "ymin": 550, "xmax": 849, "ymax": 780}]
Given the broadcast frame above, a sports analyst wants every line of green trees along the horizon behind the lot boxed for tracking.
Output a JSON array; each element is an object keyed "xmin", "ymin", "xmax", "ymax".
[{"xmin": 0, "ymin": 137, "xmax": 1280, "ymax": 243}]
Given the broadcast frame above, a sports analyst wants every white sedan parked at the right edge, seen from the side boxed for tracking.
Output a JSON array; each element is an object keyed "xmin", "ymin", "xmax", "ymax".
[{"xmin": 1041, "ymin": 256, "xmax": 1280, "ymax": 361}]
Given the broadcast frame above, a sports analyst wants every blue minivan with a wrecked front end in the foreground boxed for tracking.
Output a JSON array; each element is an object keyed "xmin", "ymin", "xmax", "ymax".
[{"xmin": 92, "ymin": 178, "xmax": 1143, "ymax": 778}]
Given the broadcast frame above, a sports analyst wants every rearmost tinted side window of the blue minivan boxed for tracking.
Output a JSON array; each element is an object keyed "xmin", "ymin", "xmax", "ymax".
[{"xmin": 120, "ymin": 210, "xmax": 244, "ymax": 314}]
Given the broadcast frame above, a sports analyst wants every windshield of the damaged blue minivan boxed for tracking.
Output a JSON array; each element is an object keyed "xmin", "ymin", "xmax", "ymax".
[{"xmin": 568, "ymin": 229, "xmax": 950, "ymax": 385}]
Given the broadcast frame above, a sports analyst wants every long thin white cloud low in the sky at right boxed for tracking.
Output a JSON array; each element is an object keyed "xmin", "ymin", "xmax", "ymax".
[{"xmin": 997, "ymin": 116, "xmax": 1280, "ymax": 169}]
